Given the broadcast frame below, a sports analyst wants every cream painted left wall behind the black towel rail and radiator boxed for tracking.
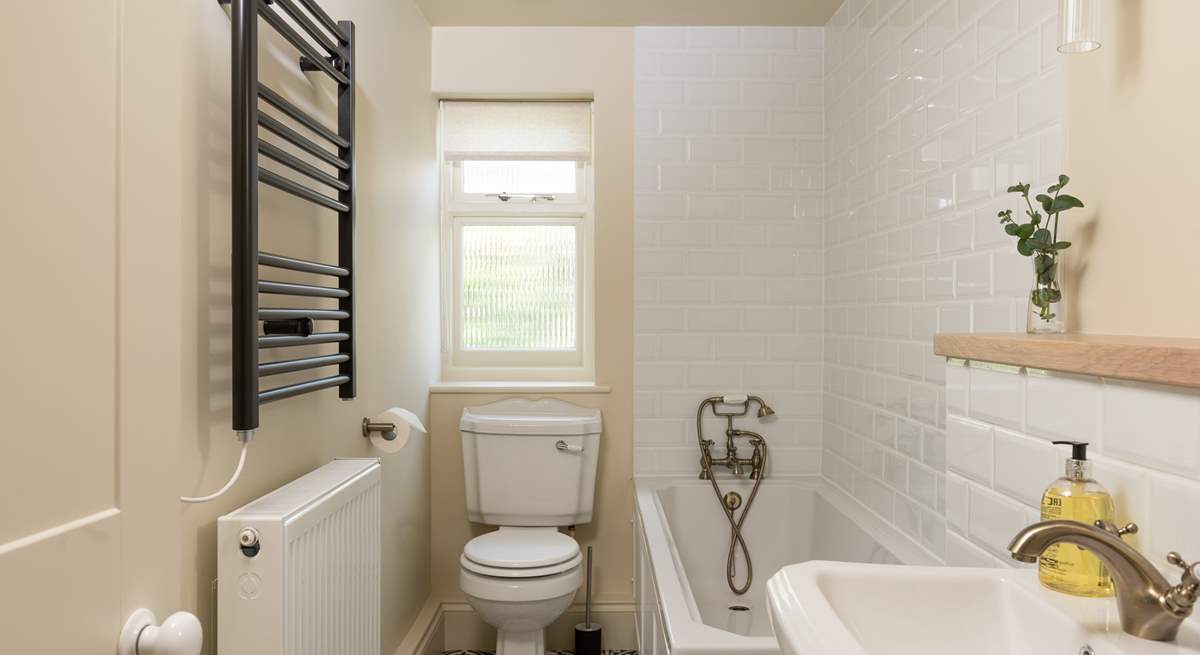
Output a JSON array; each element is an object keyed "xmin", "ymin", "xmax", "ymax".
[{"xmin": 177, "ymin": 0, "xmax": 438, "ymax": 654}]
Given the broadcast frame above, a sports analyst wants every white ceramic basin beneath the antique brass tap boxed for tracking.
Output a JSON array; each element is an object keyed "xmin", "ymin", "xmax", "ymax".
[{"xmin": 767, "ymin": 561, "xmax": 1200, "ymax": 655}]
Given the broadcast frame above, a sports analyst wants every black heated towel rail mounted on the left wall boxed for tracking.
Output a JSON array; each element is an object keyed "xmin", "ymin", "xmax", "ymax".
[{"xmin": 218, "ymin": 0, "xmax": 355, "ymax": 434}]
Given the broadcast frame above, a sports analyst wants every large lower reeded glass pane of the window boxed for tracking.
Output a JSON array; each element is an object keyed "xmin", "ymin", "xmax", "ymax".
[{"xmin": 462, "ymin": 226, "xmax": 576, "ymax": 350}]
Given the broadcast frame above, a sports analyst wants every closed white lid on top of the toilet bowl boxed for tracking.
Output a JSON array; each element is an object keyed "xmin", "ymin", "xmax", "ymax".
[{"xmin": 460, "ymin": 527, "xmax": 582, "ymax": 578}]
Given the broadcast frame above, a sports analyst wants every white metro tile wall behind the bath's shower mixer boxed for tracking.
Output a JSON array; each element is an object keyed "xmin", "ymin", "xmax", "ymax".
[{"xmin": 634, "ymin": 28, "xmax": 824, "ymax": 475}]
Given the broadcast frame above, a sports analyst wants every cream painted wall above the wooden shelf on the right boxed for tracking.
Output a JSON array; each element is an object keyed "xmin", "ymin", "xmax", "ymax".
[{"xmin": 1063, "ymin": 0, "xmax": 1200, "ymax": 337}]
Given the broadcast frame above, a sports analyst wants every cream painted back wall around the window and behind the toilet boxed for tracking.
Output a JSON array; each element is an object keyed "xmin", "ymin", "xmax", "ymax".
[{"xmin": 430, "ymin": 28, "xmax": 634, "ymax": 602}]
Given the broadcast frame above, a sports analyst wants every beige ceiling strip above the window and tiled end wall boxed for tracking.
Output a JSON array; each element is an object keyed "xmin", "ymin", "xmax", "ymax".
[{"xmin": 416, "ymin": 0, "xmax": 842, "ymax": 26}]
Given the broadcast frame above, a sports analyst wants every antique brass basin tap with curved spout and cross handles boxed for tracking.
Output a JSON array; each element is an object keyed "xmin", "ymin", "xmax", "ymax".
[{"xmin": 1008, "ymin": 521, "xmax": 1200, "ymax": 642}]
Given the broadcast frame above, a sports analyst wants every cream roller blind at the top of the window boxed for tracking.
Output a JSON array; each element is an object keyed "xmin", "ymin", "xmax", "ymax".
[{"xmin": 442, "ymin": 101, "xmax": 592, "ymax": 161}]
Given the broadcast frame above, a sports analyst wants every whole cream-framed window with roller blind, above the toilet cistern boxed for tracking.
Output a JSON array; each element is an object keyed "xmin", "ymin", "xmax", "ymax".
[{"xmin": 440, "ymin": 101, "xmax": 594, "ymax": 381}]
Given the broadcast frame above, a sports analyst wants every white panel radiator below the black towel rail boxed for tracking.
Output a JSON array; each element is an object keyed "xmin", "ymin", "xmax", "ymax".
[{"xmin": 217, "ymin": 459, "xmax": 380, "ymax": 655}]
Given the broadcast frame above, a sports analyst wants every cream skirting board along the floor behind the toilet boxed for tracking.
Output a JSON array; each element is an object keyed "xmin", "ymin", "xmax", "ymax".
[{"xmin": 395, "ymin": 597, "xmax": 637, "ymax": 655}]
